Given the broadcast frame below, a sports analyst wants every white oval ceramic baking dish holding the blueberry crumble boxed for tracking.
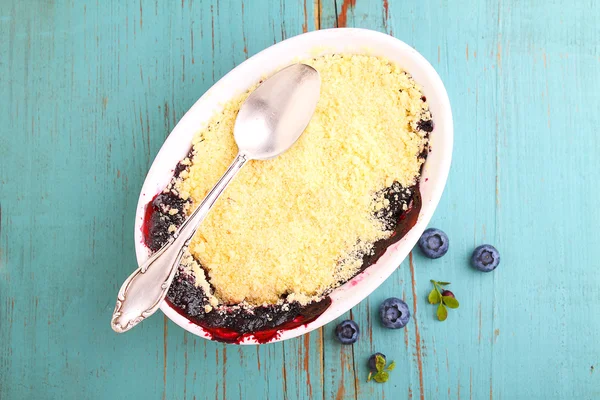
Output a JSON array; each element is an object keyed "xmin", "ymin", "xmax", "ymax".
[{"xmin": 135, "ymin": 28, "xmax": 453, "ymax": 344}]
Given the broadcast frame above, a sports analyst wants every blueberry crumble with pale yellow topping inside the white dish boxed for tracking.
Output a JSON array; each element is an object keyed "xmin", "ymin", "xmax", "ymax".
[{"xmin": 144, "ymin": 55, "xmax": 433, "ymax": 341}]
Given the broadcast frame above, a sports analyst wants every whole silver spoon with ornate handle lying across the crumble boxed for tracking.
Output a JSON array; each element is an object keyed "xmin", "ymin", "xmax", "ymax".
[{"xmin": 111, "ymin": 64, "xmax": 321, "ymax": 333}]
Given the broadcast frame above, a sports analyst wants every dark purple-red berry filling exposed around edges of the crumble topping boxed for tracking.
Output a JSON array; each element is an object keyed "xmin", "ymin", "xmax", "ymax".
[{"xmin": 143, "ymin": 139, "xmax": 433, "ymax": 343}]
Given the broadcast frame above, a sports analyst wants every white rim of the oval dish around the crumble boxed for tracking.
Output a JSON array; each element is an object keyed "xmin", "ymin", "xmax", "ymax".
[{"xmin": 134, "ymin": 28, "xmax": 454, "ymax": 344}]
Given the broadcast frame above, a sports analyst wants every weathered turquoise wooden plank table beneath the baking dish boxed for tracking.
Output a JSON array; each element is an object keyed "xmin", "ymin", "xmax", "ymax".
[{"xmin": 0, "ymin": 0, "xmax": 600, "ymax": 400}]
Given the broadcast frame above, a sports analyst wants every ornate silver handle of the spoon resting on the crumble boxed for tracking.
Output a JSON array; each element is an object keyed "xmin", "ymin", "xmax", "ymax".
[{"xmin": 110, "ymin": 154, "xmax": 248, "ymax": 333}]
